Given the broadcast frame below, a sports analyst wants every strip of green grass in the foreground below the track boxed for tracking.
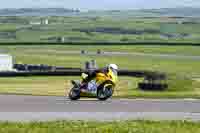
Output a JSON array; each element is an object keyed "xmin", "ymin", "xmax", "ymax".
[{"xmin": 0, "ymin": 121, "xmax": 200, "ymax": 133}]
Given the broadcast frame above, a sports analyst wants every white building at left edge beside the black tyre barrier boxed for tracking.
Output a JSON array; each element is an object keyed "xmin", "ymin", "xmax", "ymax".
[{"xmin": 0, "ymin": 54, "xmax": 13, "ymax": 72}]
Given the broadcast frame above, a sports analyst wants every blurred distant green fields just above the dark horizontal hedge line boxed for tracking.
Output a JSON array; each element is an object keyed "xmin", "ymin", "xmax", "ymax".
[{"xmin": 0, "ymin": 14, "xmax": 200, "ymax": 43}]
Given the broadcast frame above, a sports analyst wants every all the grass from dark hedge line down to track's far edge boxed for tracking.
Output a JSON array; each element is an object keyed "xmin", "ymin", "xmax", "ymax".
[{"xmin": 0, "ymin": 45, "xmax": 200, "ymax": 98}]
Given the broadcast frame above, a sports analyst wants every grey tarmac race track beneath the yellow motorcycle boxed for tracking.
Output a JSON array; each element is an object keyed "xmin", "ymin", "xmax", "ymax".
[{"xmin": 0, "ymin": 95, "xmax": 200, "ymax": 121}]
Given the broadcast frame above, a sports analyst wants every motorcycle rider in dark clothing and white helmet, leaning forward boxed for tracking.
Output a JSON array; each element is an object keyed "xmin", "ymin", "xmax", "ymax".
[{"xmin": 82, "ymin": 64, "xmax": 118, "ymax": 83}]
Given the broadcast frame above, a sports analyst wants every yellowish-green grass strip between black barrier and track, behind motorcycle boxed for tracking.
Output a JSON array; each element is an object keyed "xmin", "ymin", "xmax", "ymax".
[{"xmin": 0, "ymin": 76, "xmax": 200, "ymax": 98}]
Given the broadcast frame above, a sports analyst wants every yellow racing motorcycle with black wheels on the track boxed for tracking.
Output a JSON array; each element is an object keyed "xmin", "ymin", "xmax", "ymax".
[{"xmin": 69, "ymin": 69, "xmax": 118, "ymax": 101}]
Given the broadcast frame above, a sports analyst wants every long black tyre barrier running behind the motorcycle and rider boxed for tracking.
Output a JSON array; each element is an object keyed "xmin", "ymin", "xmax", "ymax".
[{"xmin": 4, "ymin": 64, "xmax": 167, "ymax": 81}]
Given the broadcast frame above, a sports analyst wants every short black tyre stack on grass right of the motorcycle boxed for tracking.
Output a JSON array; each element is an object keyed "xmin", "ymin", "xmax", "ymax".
[{"xmin": 138, "ymin": 83, "xmax": 168, "ymax": 91}]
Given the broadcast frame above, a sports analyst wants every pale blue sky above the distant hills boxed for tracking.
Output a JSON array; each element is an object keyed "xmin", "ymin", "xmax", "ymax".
[{"xmin": 0, "ymin": 0, "xmax": 200, "ymax": 10}]
